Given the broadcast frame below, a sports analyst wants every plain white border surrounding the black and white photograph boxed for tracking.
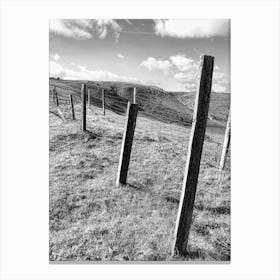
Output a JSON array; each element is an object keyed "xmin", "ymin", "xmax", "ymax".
[{"xmin": 0, "ymin": 1, "xmax": 280, "ymax": 280}]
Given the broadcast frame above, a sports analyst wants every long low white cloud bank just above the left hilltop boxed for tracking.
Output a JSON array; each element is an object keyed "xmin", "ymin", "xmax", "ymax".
[{"xmin": 50, "ymin": 61, "xmax": 142, "ymax": 83}]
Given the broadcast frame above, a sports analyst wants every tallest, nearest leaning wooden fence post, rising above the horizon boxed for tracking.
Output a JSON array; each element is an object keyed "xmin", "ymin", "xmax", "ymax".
[{"xmin": 172, "ymin": 55, "xmax": 214, "ymax": 255}]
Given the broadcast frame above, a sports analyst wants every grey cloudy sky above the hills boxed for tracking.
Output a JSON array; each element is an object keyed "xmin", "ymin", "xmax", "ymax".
[{"xmin": 49, "ymin": 19, "xmax": 230, "ymax": 92}]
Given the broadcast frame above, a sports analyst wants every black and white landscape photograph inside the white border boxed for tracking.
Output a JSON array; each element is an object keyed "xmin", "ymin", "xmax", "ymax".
[{"xmin": 49, "ymin": 18, "xmax": 231, "ymax": 263}]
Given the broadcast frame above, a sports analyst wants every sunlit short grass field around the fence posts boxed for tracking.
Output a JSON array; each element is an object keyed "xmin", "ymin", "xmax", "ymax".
[{"xmin": 49, "ymin": 80, "xmax": 230, "ymax": 261}]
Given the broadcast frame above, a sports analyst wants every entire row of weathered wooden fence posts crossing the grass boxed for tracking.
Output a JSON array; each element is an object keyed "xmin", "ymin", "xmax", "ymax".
[{"xmin": 50, "ymin": 55, "xmax": 231, "ymax": 255}]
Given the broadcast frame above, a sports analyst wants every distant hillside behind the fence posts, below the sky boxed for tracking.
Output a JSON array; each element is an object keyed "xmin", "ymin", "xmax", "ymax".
[{"xmin": 50, "ymin": 79, "xmax": 230, "ymax": 130}]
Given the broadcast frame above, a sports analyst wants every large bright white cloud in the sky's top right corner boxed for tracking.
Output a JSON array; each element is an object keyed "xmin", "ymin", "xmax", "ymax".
[{"xmin": 154, "ymin": 19, "xmax": 230, "ymax": 39}]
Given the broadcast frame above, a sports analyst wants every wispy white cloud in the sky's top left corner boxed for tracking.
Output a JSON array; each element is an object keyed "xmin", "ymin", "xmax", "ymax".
[{"xmin": 50, "ymin": 19, "xmax": 122, "ymax": 42}]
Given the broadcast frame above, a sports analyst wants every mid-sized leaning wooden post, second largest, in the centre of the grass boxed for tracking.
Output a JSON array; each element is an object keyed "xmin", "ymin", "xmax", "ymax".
[{"xmin": 116, "ymin": 102, "xmax": 138, "ymax": 186}]
